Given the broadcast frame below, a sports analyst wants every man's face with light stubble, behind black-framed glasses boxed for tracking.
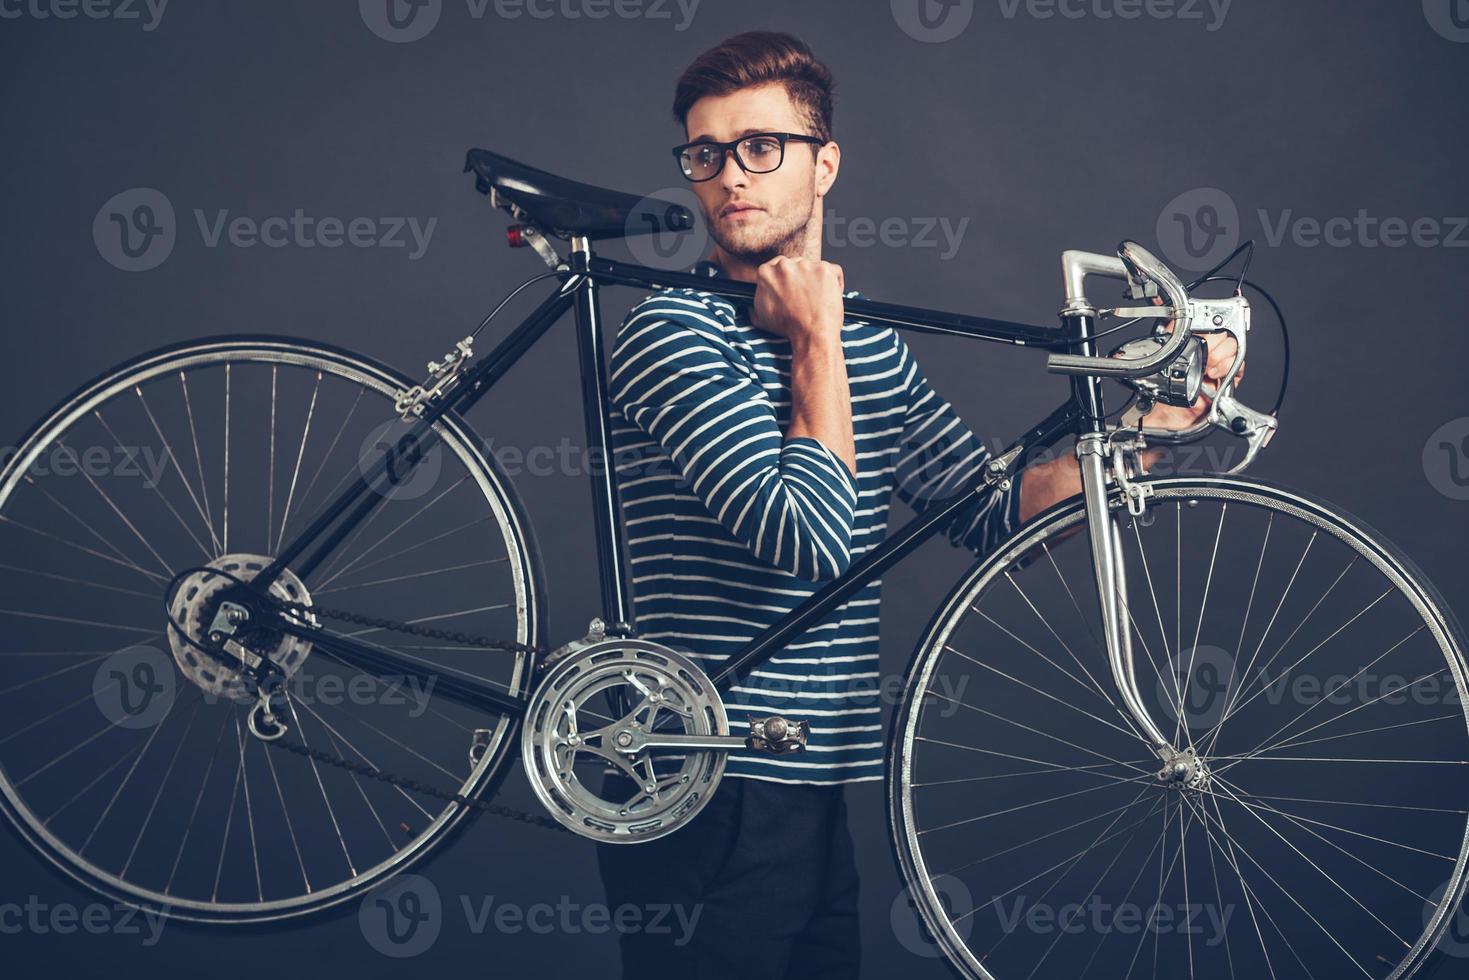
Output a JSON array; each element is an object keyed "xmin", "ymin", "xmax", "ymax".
[{"xmin": 686, "ymin": 82, "xmax": 836, "ymax": 263}]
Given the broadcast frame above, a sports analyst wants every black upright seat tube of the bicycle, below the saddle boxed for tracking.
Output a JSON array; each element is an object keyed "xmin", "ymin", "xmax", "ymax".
[{"xmin": 570, "ymin": 235, "xmax": 633, "ymax": 636}]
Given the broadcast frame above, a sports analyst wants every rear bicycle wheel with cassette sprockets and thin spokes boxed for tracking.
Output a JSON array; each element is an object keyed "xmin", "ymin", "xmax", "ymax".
[{"xmin": 0, "ymin": 336, "xmax": 544, "ymax": 921}]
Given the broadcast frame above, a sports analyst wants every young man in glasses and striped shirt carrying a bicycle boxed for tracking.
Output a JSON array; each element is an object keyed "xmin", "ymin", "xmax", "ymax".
[{"xmin": 598, "ymin": 32, "xmax": 1234, "ymax": 980}]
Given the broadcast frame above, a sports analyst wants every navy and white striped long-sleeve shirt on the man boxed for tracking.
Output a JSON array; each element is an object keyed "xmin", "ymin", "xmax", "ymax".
[{"xmin": 608, "ymin": 264, "xmax": 1019, "ymax": 783}]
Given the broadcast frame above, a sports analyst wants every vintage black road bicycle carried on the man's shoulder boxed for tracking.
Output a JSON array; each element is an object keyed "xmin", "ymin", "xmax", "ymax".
[{"xmin": 0, "ymin": 150, "xmax": 1469, "ymax": 980}]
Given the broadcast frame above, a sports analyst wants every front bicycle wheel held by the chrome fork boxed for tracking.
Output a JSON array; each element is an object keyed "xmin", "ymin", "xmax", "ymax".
[{"xmin": 887, "ymin": 478, "xmax": 1469, "ymax": 980}]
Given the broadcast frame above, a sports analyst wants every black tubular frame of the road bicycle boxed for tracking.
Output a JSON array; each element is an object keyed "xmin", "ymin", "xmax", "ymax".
[{"xmin": 248, "ymin": 238, "xmax": 1106, "ymax": 717}]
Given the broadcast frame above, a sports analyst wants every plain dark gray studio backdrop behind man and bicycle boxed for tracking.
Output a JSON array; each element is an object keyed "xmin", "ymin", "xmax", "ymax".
[{"xmin": 0, "ymin": 0, "xmax": 1469, "ymax": 980}]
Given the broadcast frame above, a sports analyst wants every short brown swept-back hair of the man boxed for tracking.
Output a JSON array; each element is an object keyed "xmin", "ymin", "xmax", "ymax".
[{"xmin": 673, "ymin": 31, "xmax": 833, "ymax": 141}]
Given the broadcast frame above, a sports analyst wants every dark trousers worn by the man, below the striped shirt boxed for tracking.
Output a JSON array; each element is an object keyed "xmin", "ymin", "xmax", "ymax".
[{"xmin": 596, "ymin": 774, "xmax": 861, "ymax": 980}]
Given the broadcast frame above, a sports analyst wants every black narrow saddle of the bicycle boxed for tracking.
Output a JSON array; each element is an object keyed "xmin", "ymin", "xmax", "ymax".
[{"xmin": 464, "ymin": 150, "xmax": 693, "ymax": 239}]
